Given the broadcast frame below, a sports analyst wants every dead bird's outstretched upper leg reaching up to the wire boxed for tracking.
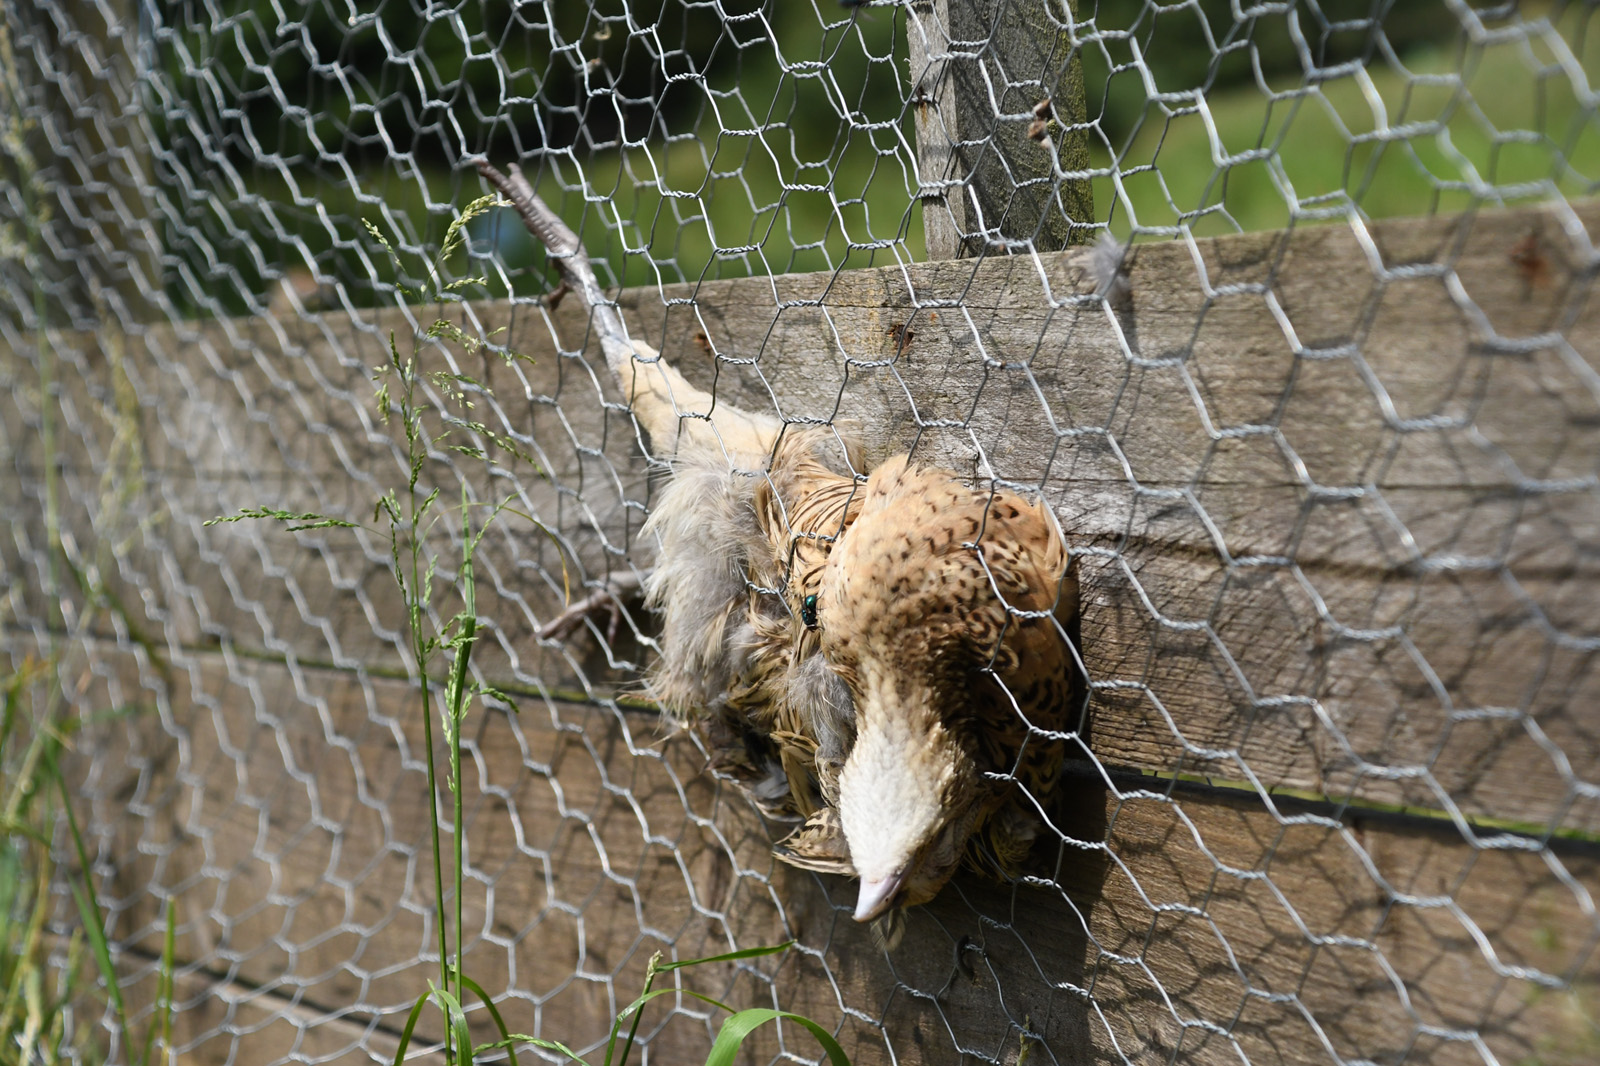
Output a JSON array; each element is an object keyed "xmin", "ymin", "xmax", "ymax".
[{"xmin": 478, "ymin": 160, "xmax": 782, "ymax": 467}]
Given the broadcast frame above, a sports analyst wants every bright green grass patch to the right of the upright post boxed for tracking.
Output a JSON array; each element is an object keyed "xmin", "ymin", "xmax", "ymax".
[{"xmin": 1094, "ymin": 5, "xmax": 1600, "ymax": 237}]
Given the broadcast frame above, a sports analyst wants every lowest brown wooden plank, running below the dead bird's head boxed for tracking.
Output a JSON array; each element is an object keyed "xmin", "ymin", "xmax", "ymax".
[{"xmin": 43, "ymin": 633, "xmax": 1600, "ymax": 1066}]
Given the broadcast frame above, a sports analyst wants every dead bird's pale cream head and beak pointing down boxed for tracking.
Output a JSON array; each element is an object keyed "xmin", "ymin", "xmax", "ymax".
[{"xmin": 838, "ymin": 669, "xmax": 990, "ymax": 922}]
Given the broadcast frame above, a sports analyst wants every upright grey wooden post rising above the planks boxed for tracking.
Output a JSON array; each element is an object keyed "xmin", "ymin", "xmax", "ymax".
[{"xmin": 907, "ymin": 0, "xmax": 1094, "ymax": 259}]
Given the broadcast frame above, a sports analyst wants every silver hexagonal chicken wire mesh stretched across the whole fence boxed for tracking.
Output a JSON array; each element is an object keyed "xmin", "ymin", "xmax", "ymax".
[{"xmin": 0, "ymin": 0, "xmax": 1600, "ymax": 1064}]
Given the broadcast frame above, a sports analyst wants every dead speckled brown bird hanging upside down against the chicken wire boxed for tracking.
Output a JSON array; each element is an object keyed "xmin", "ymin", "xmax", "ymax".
[{"xmin": 478, "ymin": 163, "xmax": 1083, "ymax": 920}]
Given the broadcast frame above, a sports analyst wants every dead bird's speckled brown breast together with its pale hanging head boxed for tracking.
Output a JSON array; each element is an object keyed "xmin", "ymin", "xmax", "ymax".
[{"xmin": 811, "ymin": 456, "xmax": 1067, "ymax": 922}]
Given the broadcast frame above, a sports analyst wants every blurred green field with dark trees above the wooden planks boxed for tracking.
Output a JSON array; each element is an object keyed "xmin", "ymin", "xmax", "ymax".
[{"xmin": 144, "ymin": 0, "xmax": 1600, "ymax": 315}]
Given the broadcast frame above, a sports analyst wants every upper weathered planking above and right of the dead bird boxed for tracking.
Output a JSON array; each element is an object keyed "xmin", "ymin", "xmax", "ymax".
[{"xmin": 531, "ymin": 205, "xmax": 1600, "ymax": 829}]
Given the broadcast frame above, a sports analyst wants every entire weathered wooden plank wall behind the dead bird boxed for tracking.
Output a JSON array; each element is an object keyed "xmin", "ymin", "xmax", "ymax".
[{"xmin": 0, "ymin": 192, "xmax": 1600, "ymax": 1066}]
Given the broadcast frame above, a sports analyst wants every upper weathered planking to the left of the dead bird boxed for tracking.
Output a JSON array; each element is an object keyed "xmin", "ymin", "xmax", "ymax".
[{"xmin": 0, "ymin": 302, "xmax": 648, "ymax": 691}]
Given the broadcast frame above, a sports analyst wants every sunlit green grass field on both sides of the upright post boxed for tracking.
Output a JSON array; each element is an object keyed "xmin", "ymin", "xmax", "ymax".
[{"xmin": 507, "ymin": 10, "xmax": 1600, "ymax": 294}]
